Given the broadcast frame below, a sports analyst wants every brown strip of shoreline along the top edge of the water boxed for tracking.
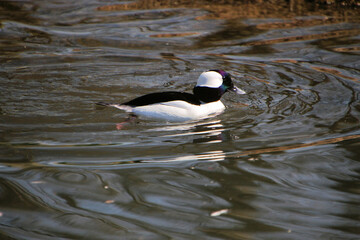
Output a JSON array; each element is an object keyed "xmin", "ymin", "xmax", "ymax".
[{"xmin": 97, "ymin": 0, "xmax": 360, "ymax": 19}]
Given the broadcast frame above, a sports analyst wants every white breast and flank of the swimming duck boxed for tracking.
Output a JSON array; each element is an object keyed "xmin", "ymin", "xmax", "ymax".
[{"xmin": 132, "ymin": 101, "xmax": 225, "ymax": 122}]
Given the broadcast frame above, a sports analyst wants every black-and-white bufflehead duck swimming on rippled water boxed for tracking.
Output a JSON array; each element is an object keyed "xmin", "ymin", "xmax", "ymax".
[{"xmin": 97, "ymin": 70, "xmax": 245, "ymax": 122}]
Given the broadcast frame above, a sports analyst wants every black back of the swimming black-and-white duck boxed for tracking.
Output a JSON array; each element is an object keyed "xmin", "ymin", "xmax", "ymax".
[{"xmin": 122, "ymin": 92, "xmax": 201, "ymax": 107}]
